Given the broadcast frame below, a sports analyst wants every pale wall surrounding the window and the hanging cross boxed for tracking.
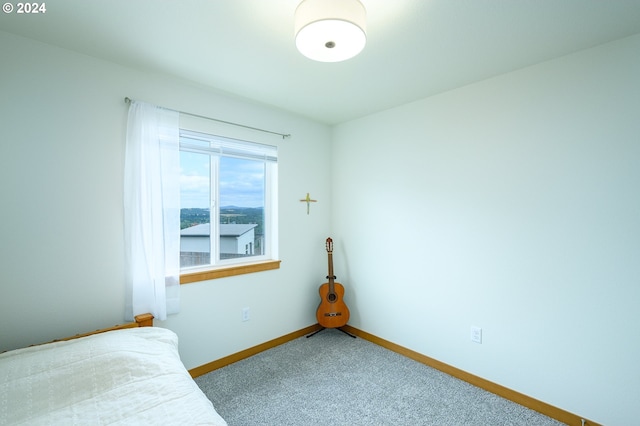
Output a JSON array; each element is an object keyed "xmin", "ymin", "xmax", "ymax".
[{"xmin": 0, "ymin": 32, "xmax": 331, "ymax": 368}]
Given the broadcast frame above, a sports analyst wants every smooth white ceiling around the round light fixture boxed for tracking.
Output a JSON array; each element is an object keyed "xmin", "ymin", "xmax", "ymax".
[{"xmin": 0, "ymin": 0, "xmax": 640, "ymax": 124}]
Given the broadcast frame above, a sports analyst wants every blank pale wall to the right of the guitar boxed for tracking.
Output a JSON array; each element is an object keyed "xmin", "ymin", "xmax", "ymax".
[{"xmin": 332, "ymin": 36, "xmax": 640, "ymax": 425}]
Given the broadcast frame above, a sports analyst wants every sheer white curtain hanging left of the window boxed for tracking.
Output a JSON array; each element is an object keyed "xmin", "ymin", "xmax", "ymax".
[{"xmin": 124, "ymin": 101, "xmax": 180, "ymax": 320}]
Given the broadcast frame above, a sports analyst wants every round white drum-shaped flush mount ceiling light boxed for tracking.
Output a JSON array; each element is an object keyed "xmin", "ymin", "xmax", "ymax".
[{"xmin": 295, "ymin": 0, "xmax": 367, "ymax": 62}]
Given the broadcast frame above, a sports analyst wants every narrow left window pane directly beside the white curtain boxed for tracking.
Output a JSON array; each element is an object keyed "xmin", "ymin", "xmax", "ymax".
[{"xmin": 180, "ymin": 151, "xmax": 211, "ymax": 268}]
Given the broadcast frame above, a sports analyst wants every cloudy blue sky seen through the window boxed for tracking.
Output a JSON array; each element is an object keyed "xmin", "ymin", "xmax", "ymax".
[{"xmin": 180, "ymin": 152, "xmax": 264, "ymax": 208}]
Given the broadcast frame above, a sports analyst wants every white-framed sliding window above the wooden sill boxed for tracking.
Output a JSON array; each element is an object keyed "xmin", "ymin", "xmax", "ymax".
[{"xmin": 180, "ymin": 130, "xmax": 277, "ymax": 279}]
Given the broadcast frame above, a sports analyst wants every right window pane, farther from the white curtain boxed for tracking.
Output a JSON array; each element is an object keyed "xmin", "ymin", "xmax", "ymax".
[{"xmin": 218, "ymin": 157, "xmax": 265, "ymax": 260}]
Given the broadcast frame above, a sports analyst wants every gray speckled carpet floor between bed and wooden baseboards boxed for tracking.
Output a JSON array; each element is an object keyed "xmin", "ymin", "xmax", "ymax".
[{"xmin": 195, "ymin": 329, "xmax": 562, "ymax": 426}]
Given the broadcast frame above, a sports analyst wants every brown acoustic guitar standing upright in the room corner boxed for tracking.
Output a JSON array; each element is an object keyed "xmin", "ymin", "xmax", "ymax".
[{"xmin": 316, "ymin": 238, "xmax": 349, "ymax": 328}]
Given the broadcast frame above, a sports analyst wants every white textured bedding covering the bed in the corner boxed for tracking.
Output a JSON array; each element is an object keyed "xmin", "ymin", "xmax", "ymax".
[{"xmin": 0, "ymin": 327, "xmax": 226, "ymax": 426}]
